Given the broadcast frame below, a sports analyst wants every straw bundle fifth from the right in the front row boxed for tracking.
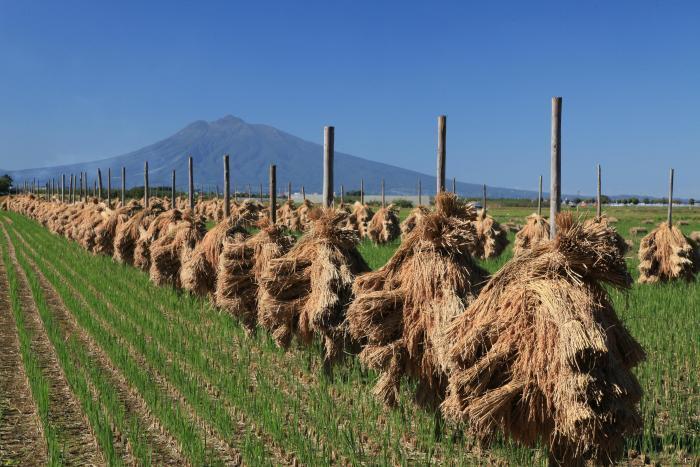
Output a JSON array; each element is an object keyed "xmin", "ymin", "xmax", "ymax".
[{"xmin": 180, "ymin": 216, "xmax": 245, "ymax": 295}]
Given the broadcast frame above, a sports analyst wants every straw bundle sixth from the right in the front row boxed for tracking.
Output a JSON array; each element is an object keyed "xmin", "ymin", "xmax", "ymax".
[{"xmin": 149, "ymin": 210, "xmax": 207, "ymax": 288}]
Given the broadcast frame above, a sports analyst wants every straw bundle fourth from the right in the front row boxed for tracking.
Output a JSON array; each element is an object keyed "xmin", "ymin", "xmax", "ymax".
[{"xmin": 215, "ymin": 219, "xmax": 294, "ymax": 332}]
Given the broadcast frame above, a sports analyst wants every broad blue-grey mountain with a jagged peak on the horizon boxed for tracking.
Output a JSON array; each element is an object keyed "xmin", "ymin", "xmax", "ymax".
[{"xmin": 0, "ymin": 115, "xmax": 537, "ymax": 198}]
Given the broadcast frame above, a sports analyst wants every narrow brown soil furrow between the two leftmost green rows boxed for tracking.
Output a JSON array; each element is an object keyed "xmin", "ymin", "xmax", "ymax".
[{"xmin": 3, "ymin": 226, "xmax": 105, "ymax": 465}]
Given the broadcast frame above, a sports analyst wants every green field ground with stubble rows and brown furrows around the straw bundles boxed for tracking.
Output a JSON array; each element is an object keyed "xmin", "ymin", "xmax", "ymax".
[{"xmin": 0, "ymin": 207, "xmax": 700, "ymax": 465}]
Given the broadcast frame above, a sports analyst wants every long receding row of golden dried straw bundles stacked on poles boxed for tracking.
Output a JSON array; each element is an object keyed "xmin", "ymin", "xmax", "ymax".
[{"xmin": 9, "ymin": 193, "xmax": 690, "ymax": 465}]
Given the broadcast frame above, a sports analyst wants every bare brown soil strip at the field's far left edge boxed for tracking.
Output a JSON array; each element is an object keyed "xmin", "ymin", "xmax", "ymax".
[{"xmin": 0, "ymin": 243, "xmax": 47, "ymax": 465}]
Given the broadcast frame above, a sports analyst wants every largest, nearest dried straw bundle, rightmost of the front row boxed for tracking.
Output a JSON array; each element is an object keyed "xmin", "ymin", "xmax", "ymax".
[{"xmin": 442, "ymin": 213, "xmax": 645, "ymax": 465}]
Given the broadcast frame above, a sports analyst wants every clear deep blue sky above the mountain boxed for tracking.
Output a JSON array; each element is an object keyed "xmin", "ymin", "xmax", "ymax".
[{"xmin": 0, "ymin": 0, "xmax": 700, "ymax": 198}]
